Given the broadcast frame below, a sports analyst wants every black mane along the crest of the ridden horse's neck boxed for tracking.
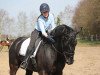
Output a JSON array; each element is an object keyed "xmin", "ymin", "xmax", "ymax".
[{"xmin": 50, "ymin": 24, "xmax": 74, "ymax": 37}]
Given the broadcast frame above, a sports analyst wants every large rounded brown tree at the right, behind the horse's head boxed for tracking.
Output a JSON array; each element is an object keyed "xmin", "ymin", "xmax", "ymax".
[{"xmin": 73, "ymin": 0, "xmax": 100, "ymax": 40}]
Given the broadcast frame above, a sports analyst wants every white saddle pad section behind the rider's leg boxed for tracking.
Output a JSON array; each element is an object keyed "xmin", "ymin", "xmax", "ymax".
[{"xmin": 19, "ymin": 38, "xmax": 30, "ymax": 56}]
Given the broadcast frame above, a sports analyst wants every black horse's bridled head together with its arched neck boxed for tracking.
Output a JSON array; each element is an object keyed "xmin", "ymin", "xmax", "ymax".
[{"xmin": 52, "ymin": 25, "xmax": 78, "ymax": 65}]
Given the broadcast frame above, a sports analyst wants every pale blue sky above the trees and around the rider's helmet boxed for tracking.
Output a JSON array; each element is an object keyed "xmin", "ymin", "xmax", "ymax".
[{"xmin": 0, "ymin": 0, "xmax": 80, "ymax": 17}]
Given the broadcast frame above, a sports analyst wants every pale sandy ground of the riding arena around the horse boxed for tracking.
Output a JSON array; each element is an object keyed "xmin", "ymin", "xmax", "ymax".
[{"xmin": 0, "ymin": 46, "xmax": 100, "ymax": 75}]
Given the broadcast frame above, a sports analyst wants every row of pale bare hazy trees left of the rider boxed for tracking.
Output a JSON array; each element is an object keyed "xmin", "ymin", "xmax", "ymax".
[{"xmin": 0, "ymin": 9, "xmax": 37, "ymax": 38}]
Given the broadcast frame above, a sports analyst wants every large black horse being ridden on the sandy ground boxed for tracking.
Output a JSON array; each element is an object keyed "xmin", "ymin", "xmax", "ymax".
[{"xmin": 9, "ymin": 24, "xmax": 79, "ymax": 75}]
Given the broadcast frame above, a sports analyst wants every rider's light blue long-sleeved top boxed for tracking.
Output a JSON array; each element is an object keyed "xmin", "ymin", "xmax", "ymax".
[{"xmin": 35, "ymin": 13, "xmax": 56, "ymax": 36}]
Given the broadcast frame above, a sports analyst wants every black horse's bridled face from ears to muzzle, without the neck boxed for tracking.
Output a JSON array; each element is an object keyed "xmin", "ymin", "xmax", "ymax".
[{"xmin": 62, "ymin": 31, "xmax": 77, "ymax": 65}]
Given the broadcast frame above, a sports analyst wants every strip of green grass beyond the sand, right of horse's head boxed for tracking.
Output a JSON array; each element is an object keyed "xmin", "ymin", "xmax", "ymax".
[{"xmin": 78, "ymin": 40, "xmax": 100, "ymax": 46}]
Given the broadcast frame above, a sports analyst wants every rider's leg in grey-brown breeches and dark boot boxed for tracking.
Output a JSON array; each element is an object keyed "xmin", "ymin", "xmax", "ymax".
[{"xmin": 21, "ymin": 30, "xmax": 39, "ymax": 69}]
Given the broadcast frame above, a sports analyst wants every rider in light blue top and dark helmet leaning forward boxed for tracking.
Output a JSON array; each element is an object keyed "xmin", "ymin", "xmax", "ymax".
[{"xmin": 21, "ymin": 3, "xmax": 56, "ymax": 69}]
